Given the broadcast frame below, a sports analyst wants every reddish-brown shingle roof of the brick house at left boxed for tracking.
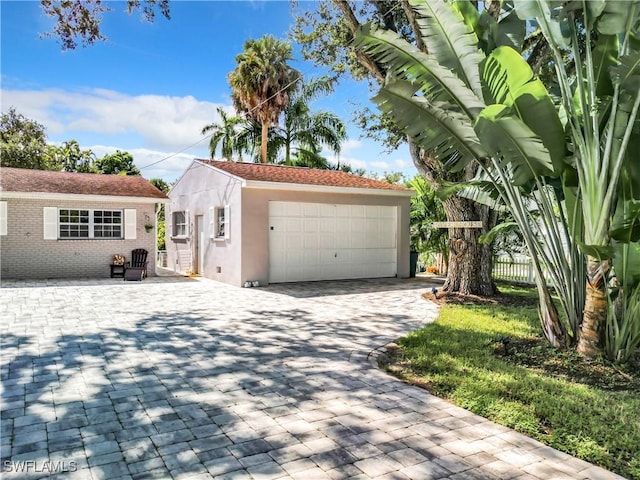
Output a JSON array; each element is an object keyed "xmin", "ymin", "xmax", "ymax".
[{"xmin": 0, "ymin": 167, "xmax": 167, "ymax": 199}]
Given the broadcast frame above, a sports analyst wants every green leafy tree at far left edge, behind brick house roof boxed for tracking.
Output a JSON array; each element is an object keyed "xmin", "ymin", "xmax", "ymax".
[{"xmin": 0, "ymin": 107, "xmax": 50, "ymax": 170}]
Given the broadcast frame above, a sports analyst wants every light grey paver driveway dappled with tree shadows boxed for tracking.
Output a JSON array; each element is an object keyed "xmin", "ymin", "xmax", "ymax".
[{"xmin": 0, "ymin": 278, "xmax": 615, "ymax": 480}]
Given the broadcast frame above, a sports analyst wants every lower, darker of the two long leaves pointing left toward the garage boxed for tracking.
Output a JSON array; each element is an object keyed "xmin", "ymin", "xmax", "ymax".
[{"xmin": 373, "ymin": 80, "xmax": 487, "ymax": 172}]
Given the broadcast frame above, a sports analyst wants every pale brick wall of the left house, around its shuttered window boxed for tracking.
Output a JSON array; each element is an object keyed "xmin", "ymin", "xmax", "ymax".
[{"xmin": 0, "ymin": 198, "xmax": 156, "ymax": 279}]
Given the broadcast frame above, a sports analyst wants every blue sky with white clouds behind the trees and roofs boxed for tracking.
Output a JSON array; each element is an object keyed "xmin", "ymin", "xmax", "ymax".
[{"xmin": 0, "ymin": 0, "xmax": 415, "ymax": 181}]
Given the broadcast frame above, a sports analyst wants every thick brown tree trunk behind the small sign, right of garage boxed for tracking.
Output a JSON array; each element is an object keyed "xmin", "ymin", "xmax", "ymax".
[{"xmin": 443, "ymin": 197, "xmax": 496, "ymax": 296}]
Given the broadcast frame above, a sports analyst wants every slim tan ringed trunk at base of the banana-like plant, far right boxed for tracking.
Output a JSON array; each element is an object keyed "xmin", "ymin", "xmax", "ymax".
[{"xmin": 577, "ymin": 257, "xmax": 609, "ymax": 358}]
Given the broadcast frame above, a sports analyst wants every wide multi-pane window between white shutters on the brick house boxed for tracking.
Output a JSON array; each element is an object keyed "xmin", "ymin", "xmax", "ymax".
[{"xmin": 58, "ymin": 208, "xmax": 122, "ymax": 239}]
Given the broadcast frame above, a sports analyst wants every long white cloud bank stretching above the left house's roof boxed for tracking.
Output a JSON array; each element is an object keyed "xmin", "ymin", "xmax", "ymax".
[{"xmin": 2, "ymin": 89, "xmax": 230, "ymax": 151}]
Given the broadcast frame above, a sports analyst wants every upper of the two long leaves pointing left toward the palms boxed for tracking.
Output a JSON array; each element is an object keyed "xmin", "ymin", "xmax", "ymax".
[{"xmin": 355, "ymin": 25, "xmax": 485, "ymax": 119}]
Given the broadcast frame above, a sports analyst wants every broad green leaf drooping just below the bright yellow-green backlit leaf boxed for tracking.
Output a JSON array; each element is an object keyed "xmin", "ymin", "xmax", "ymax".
[{"xmin": 474, "ymin": 105, "xmax": 553, "ymax": 186}]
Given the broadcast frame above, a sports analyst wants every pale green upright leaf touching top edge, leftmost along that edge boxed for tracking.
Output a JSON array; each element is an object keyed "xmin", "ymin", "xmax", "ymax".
[{"xmin": 409, "ymin": 0, "xmax": 484, "ymax": 98}]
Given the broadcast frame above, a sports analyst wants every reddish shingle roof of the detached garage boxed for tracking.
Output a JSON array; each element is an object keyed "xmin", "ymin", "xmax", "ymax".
[{"xmin": 198, "ymin": 160, "xmax": 410, "ymax": 191}]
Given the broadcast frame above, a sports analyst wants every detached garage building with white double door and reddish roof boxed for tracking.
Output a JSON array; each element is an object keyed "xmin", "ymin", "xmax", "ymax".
[{"xmin": 165, "ymin": 160, "xmax": 413, "ymax": 286}]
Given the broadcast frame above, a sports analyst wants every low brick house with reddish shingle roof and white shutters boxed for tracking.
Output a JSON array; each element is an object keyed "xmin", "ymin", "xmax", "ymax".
[{"xmin": 0, "ymin": 168, "xmax": 167, "ymax": 279}]
